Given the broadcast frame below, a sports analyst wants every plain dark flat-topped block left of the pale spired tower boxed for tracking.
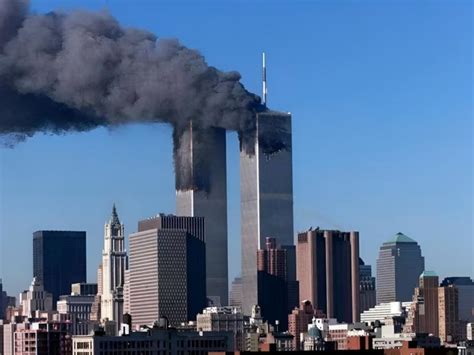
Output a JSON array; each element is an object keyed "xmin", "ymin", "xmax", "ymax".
[{"xmin": 33, "ymin": 231, "xmax": 86, "ymax": 306}]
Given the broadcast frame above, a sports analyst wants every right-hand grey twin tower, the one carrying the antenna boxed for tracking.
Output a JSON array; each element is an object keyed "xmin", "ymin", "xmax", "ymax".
[{"xmin": 240, "ymin": 111, "xmax": 294, "ymax": 315}]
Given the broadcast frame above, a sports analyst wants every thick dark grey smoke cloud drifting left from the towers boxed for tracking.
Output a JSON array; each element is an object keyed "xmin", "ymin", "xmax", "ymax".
[{"xmin": 0, "ymin": 0, "xmax": 286, "ymax": 189}]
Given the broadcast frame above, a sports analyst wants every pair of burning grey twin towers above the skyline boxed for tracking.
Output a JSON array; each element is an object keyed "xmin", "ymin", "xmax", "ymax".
[{"xmin": 176, "ymin": 111, "xmax": 294, "ymax": 314}]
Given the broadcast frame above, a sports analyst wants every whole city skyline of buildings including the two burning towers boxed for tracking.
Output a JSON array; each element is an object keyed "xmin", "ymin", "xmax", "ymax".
[{"xmin": 0, "ymin": 107, "xmax": 474, "ymax": 355}]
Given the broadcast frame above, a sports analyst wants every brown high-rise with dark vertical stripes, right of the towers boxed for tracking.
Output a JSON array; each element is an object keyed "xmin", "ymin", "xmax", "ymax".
[{"xmin": 296, "ymin": 229, "xmax": 360, "ymax": 323}]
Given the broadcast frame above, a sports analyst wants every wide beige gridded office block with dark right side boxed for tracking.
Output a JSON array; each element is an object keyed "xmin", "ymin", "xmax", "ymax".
[{"xmin": 129, "ymin": 214, "xmax": 206, "ymax": 326}]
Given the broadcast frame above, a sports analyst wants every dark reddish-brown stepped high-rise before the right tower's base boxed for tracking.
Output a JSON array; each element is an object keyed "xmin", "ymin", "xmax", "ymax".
[{"xmin": 257, "ymin": 238, "xmax": 288, "ymax": 331}]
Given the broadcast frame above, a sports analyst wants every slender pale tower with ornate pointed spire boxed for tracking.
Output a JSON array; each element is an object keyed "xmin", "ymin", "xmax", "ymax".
[{"xmin": 100, "ymin": 205, "xmax": 127, "ymax": 329}]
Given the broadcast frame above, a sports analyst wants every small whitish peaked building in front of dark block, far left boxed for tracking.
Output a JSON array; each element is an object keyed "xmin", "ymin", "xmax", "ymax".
[{"xmin": 20, "ymin": 277, "xmax": 53, "ymax": 317}]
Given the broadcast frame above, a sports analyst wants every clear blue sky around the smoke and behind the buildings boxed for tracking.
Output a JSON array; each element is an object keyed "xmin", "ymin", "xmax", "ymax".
[{"xmin": 0, "ymin": 0, "xmax": 474, "ymax": 294}]
